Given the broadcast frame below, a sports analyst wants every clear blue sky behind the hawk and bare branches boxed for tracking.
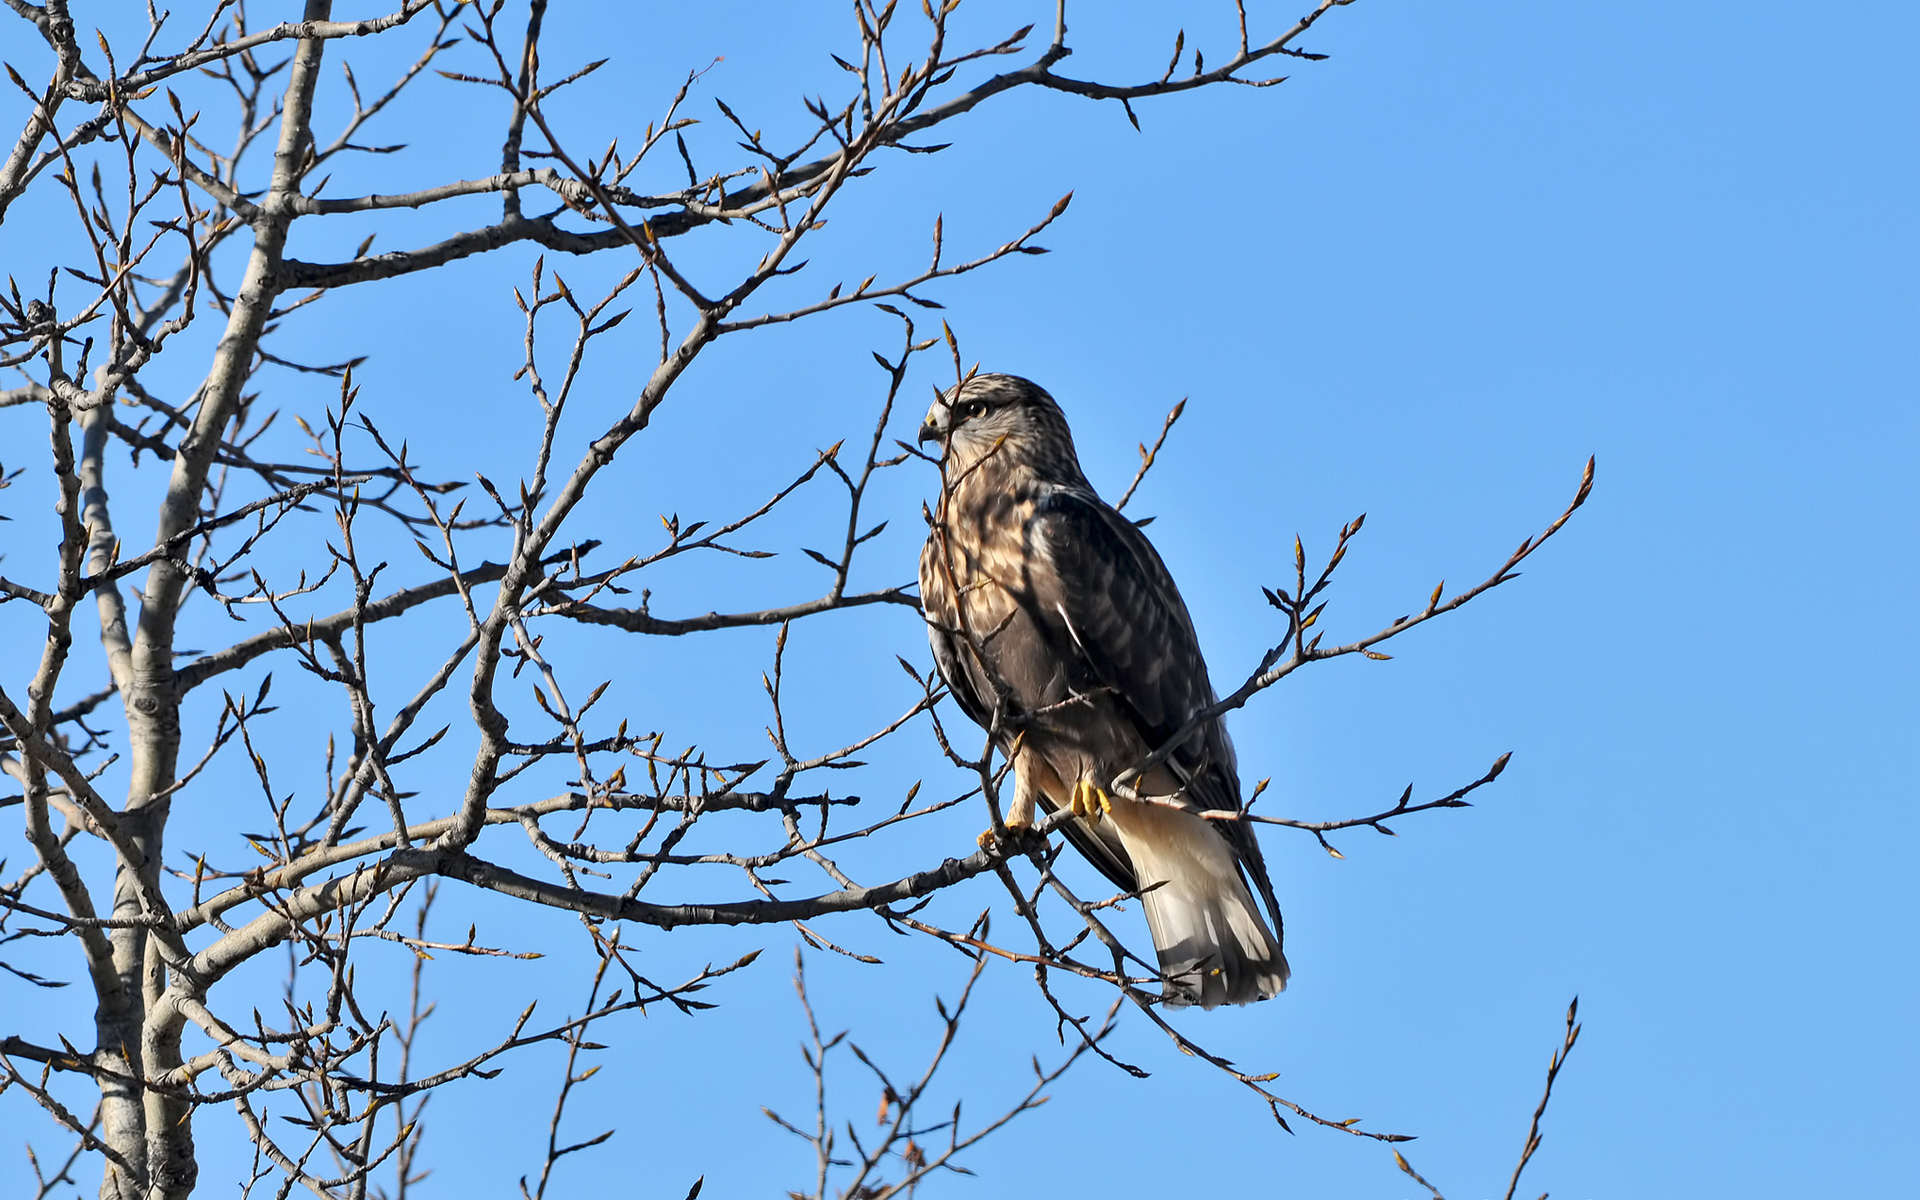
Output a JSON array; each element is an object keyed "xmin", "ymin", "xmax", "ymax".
[{"xmin": 0, "ymin": 0, "xmax": 1920, "ymax": 1200}]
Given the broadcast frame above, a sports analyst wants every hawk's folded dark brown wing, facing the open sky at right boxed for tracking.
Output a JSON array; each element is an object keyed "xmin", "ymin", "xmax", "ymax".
[{"xmin": 1027, "ymin": 488, "xmax": 1279, "ymax": 924}]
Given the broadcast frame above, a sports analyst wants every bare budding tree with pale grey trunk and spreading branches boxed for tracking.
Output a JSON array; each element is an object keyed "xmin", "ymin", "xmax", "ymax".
[{"xmin": 0, "ymin": 0, "xmax": 1592, "ymax": 1196}]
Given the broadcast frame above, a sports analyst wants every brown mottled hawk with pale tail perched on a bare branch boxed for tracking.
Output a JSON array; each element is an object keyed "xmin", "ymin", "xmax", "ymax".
[{"xmin": 920, "ymin": 374, "xmax": 1288, "ymax": 1008}]
